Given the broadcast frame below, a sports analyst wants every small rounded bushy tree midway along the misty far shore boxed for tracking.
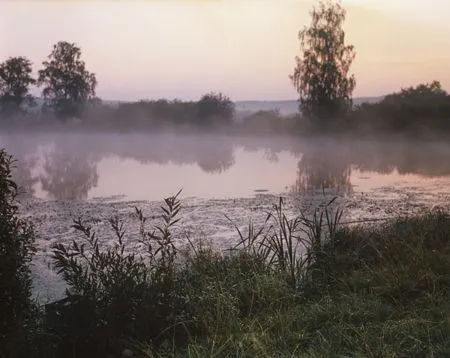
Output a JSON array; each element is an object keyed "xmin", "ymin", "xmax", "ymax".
[{"xmin": 197, "ymin": 92, "xmax": 235, "ymax": 124}]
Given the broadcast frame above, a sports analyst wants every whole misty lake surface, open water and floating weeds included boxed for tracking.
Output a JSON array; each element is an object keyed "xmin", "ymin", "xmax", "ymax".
[{"xmin": 0, "ymin": 133, "xmax": 450, "ymax": 302}]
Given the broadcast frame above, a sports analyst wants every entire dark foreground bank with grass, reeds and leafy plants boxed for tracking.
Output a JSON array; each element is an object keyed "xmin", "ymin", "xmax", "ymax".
[{"xmin": 4, "ymin": 193, "xmax": 450, "ymax": 357}]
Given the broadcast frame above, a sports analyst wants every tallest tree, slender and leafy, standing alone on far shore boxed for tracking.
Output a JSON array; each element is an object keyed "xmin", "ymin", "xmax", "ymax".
[{"xmin": 290, "ymin": 1, "xmax": 356, "ymax": 123}]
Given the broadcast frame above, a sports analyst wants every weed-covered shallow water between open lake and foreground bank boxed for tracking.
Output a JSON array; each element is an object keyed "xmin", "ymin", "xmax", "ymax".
[{"xmin": 20, "ymin": 183, "xmax": 450, "ymax": 303}]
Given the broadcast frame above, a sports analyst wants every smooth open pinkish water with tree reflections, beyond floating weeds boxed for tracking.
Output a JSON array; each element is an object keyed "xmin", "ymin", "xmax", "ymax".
[{"xmin": 0, "ymin": 133, "xmax": 450, "ymax": 200}]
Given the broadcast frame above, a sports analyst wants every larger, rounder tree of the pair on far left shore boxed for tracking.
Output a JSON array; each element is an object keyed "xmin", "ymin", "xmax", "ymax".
[{"xmin": 38, "ymin": 41, "xmax": 97, "ymax": 118}]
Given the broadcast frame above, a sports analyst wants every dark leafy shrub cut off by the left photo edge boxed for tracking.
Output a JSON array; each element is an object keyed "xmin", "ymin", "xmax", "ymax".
[{"xmin": 0, "ymin": 150, "xmax": 35, "ymax": 357}]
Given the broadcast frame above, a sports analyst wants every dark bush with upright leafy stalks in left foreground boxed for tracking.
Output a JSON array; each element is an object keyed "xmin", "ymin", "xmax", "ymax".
[{"xmin": 46, "ymin": 192, "xmax": 180, "ymax": 357}]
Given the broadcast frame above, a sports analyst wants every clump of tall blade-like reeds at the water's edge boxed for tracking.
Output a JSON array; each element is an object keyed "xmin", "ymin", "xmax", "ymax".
[{"xmin": 227, "ymin": 198, "xmax": 343, "ymax": 289}]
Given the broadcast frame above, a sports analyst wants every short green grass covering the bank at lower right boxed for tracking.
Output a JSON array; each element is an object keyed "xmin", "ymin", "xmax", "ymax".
[{"xmin": 149, "ymin": 213, "xmax": 450, "ymax": 357}]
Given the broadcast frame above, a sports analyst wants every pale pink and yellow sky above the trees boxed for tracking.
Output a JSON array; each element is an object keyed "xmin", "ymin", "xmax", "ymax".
[{"xmin": 0, "ymin": 0, "xmax": 450, "ymax": 100}]
